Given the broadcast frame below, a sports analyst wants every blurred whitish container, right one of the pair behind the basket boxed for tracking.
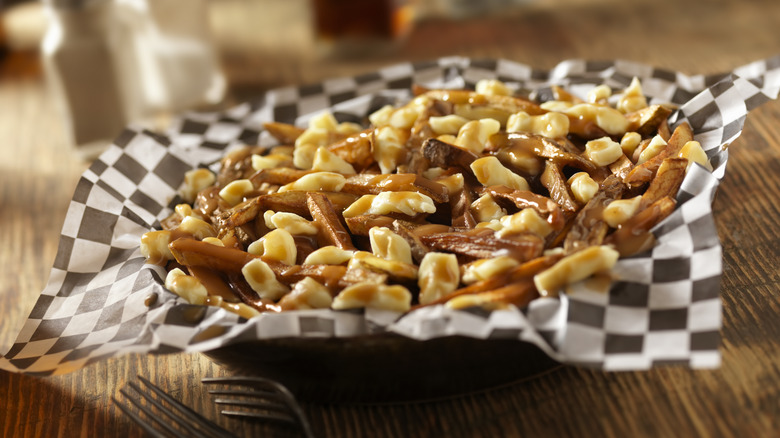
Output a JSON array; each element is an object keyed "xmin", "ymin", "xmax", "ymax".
[{"xmin": 110, "ymin": 0, "xmax": 226, "ymax": 120}]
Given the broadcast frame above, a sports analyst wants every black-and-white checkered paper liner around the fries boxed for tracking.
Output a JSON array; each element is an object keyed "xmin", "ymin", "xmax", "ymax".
[{"xmin": 0, "ymin": 57, "xmax": 780, "ymax": 376}]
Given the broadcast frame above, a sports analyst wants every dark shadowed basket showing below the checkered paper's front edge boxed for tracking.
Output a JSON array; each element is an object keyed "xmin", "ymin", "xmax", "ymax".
[{"xmin": 205, "ymin": 334, "xmax": 560, "ymax": 403}]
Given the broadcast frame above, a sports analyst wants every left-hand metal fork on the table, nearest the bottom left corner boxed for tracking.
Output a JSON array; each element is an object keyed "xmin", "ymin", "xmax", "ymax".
[{"xmin": 112, "ymin": 376, "xmax": 236, "ymax": 438}]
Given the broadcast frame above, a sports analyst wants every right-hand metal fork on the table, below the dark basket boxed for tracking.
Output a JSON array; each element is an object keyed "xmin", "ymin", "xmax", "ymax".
[{"xmin": 201, "ymin": 377, "xmax": 314, "ymax": 438}]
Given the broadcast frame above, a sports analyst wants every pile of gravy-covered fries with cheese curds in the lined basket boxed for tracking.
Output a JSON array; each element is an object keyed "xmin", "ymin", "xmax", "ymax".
[{"xmin": 141, "ymin": 79, "xmax": 709, "ymax": 318}]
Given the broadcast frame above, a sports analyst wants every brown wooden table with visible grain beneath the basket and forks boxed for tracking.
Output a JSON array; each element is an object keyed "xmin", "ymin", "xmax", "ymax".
[{"xmin": 0, "ymin": 0, "xmax": 780, "ymax": 437}]
